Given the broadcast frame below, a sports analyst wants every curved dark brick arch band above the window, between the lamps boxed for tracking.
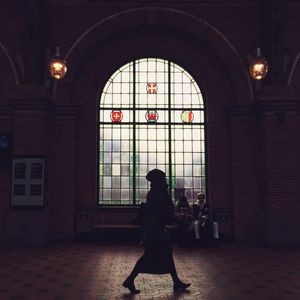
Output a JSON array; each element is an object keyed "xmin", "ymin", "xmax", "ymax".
[{"xmin": 55, "ymin": 7, "xmax": 253, "ymax": 104}]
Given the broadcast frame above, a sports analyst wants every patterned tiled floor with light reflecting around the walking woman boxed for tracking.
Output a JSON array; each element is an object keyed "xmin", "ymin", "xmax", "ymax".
[{"xmin": 0, "ymin": 243, "xmax": 300, "ymax": 300}]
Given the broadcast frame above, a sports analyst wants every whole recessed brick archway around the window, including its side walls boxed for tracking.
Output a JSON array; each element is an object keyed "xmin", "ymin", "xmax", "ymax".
[{"xmin": 54, "ymin": 8, "xmax": 253, "ymax": 241}]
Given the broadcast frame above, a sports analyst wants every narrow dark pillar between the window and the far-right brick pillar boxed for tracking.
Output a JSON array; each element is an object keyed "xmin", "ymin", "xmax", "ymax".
[{"xmin": 227, "ymin": 106, "xmax": 260, "ymax": 243}]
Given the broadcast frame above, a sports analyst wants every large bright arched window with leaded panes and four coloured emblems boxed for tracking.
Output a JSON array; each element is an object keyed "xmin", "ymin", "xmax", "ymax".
[{"xmin": 98, "ymin": 58, "xmax": 206, "ymax": 205}]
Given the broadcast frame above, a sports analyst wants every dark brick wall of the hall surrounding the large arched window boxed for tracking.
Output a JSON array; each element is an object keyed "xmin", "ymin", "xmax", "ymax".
[{"xmin": 0, "ymin": 1, "xmax": 300, "ymax": 242}]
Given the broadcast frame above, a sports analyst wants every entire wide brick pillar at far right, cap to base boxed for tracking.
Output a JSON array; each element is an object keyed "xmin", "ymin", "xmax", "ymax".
[{"xmin": 257, "ymin": 100, "xmax": 300, "ymax": 245}]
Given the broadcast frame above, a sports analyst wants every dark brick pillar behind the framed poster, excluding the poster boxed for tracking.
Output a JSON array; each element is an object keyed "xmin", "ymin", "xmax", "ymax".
[{"xmin": 6, "ymin": 85, "xmax": 51, "ymax": 245}]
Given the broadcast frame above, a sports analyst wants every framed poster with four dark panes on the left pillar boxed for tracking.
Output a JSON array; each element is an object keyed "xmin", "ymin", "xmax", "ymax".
[{"xmin": 11, "ymin": 157, "xmax": 45, "ymax": 207}]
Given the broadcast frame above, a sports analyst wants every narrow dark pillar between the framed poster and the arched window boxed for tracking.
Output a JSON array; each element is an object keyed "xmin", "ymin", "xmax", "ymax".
[{"xmin": 48, "ymin": 105, "xmax": 80, "ymax": 240}]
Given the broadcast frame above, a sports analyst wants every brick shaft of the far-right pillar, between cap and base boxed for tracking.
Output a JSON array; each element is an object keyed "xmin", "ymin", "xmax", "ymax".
[{"xmin": 262, "ymin": 111, "xmax": 300, "ymax": 209}]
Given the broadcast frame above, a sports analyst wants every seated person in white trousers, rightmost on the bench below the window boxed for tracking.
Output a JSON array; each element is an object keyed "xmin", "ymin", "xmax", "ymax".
[{"xmin": 193, "ymin": 193, "xmax": 219, "ymax": 240}]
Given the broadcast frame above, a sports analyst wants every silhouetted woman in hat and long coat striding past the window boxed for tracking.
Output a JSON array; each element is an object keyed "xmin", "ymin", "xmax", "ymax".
[{"xmin": 123, "ymin": 169, "xmax": 190, "ymax": 293}]
